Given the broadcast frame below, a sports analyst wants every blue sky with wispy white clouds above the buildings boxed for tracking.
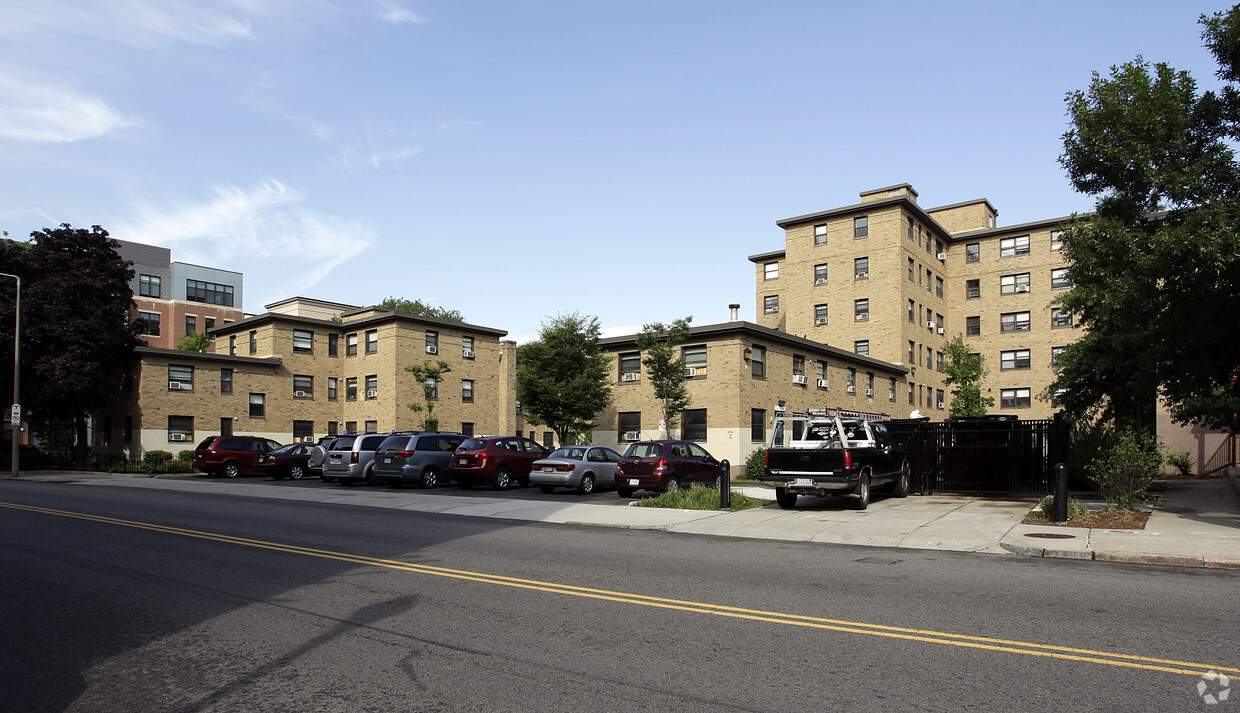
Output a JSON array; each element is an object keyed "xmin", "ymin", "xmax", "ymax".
[{"xmin": 0, "ymin": 0, "xmax": 1226, "ymax": 342}]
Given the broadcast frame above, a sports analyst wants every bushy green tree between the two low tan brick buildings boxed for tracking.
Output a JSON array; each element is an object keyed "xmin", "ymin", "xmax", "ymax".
[{"xmin": 517, "ymin": 312, "xmax": 611, "ymax": 445}]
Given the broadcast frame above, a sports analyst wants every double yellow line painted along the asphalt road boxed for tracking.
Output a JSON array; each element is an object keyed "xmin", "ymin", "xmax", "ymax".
[{"xmin": 0, "ymin": 502, "xmax": 1240, "ymax": 677}]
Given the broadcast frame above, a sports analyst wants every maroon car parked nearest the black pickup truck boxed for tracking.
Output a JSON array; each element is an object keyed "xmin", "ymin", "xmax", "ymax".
[{"xmin": 616, "ymin": 440, "xmax": 724, "ymax": 497}]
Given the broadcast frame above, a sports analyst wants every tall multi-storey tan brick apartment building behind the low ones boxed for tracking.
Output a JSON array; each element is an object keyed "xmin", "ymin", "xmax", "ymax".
[{"xmin": 749, "ymin": 184, "xmax": 1079, "ymax": 419}]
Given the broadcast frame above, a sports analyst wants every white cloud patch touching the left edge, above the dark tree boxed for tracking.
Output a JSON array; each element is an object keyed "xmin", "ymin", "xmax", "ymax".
[{"xmin": 0, "ymin": 74, "xmax": 138, "ymax": 143}]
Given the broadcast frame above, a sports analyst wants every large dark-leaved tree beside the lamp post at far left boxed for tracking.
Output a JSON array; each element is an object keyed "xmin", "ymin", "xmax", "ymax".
[{"xmin": 0, "ymin": 223, "xmax": 138, "ymax": 463}]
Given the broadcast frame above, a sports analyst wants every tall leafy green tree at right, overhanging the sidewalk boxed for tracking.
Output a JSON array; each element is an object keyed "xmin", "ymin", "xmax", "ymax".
[{"xmin": 1042, "ymin": 6, "xmax": 1240, "ymax": 432}]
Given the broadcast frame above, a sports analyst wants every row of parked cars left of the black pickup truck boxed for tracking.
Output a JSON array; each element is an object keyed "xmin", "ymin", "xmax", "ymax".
[{"xmin": 193, "ymin": 432, "xmax": 727, "ymax": 497}]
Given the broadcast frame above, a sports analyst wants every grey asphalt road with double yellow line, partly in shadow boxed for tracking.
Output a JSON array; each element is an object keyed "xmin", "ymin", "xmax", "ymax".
[{"xmin": 0, "ymin": 481, "xmax": 1240, "ymax": 713}]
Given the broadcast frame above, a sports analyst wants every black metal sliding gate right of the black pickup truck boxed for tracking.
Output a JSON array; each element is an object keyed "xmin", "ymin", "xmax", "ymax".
[{"xmin": 887, "ymin": 417, "xmax": 1068, "ymax": 495}]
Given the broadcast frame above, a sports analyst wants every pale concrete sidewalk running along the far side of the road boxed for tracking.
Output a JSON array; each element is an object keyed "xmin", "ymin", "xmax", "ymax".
[{"xmin": 2, "ymin": 471, "xmax": 1240, "ymax": 569}]
